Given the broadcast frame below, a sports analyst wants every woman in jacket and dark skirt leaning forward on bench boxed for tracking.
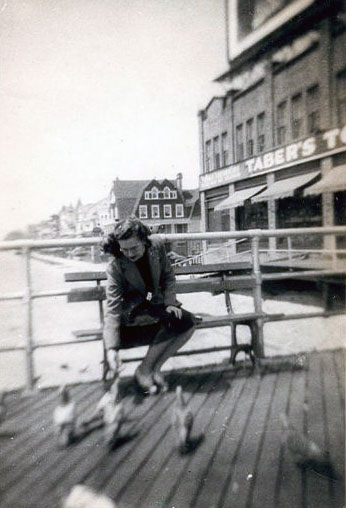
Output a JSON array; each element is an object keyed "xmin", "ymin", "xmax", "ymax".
[{"xmin": 103, "ymin": 217, "xmax": 195, "ymax": 393}]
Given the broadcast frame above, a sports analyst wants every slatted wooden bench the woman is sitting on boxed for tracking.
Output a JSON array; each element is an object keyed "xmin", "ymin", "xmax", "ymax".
[{"xmin": 65, "ymin": 262, "xmax": 282, "ymax": 370}]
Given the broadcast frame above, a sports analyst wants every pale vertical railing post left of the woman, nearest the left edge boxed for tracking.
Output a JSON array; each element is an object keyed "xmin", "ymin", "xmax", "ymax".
[{"xmin": 23, "ymin": 247, "xmax": 35, "ymax": 392}]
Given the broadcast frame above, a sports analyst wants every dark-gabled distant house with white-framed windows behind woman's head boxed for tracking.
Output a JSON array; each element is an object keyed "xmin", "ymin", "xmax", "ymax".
[{"xmin": 110, "ymin": 173, "xmax": 201, "ymax": 255}]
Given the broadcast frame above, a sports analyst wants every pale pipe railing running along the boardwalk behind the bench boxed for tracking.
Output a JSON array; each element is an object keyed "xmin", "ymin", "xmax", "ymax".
[{"xmin": 0, "ymin": 226, "xmax": 346, "ymax": 390}]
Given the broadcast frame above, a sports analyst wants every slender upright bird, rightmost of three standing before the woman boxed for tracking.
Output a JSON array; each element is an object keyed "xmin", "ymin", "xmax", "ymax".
[{"xmin": 172, "ymin": 386, "xmax": 193, "ymax": 454}]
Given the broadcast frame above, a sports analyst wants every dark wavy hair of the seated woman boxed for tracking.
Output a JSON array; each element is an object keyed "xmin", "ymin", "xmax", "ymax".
[{"xmin": 102, "ymin": 216, "xmax": 151, "ymax": 258}]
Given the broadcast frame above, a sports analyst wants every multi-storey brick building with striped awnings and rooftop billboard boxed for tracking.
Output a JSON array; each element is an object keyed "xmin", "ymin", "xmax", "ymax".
[{"xmin": 199, "ymin": 0, "xmax": 346, "ymax": 248}]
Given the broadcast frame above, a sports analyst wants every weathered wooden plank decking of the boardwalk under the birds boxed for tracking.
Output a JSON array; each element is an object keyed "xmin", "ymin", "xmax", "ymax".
[{"xmin": 0, "ymin": 350, "xmax": 345, "ymax": 508}]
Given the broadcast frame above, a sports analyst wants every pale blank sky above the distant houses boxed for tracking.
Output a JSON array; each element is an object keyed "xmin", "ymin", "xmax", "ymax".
[{"xmin": 0, "ymin": 0, "xmax": 227, "ymax": 239}]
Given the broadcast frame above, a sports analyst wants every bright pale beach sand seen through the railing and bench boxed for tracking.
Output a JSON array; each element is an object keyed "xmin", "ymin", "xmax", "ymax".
[{"xmin": 0, "ymin": 253, "xmax": 346, "ymax": 390}]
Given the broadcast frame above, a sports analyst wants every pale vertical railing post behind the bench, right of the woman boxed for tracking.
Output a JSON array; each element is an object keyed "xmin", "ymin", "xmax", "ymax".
[{"xmin": 251, "ymin": 236, "xmax": 264, "ymax": 358}]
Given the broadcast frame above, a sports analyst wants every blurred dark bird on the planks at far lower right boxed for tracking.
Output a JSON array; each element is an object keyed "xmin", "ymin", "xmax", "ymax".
[{"xmin": 280, "ymin": 413, "xmax": 339, "ymax": 480}]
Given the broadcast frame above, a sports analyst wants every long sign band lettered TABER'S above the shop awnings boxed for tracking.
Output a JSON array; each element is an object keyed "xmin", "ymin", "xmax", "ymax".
[{"xmin": 200, "ymin": 125, "xmax": 346, "ymax": 190}]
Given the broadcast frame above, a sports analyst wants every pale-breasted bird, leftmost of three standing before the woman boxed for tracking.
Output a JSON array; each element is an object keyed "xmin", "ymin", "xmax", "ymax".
[{"xmin": 53, "ymin": 386, "xmax": 76, "ymax": 447}]
